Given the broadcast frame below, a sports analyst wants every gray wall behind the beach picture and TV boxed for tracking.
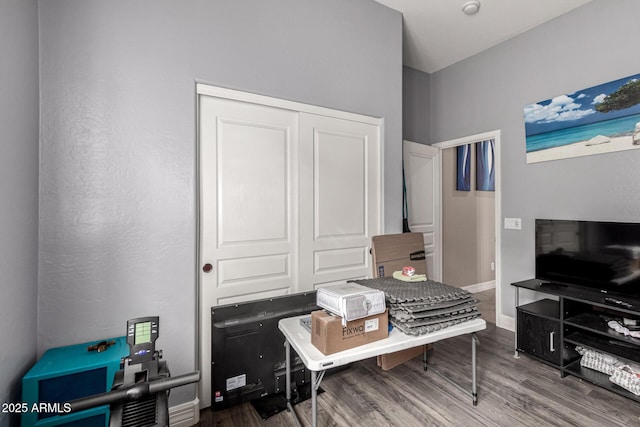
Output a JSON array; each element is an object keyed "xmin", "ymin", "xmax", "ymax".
[{"xmin": 430, "ymin": 0, "xmax": 640, "ymax": 316}]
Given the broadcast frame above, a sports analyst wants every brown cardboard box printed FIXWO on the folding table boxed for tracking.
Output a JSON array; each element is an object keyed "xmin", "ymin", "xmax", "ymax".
[{"xmin": 311, "ymin": 310, "xmax": 389, "ymax": 354}]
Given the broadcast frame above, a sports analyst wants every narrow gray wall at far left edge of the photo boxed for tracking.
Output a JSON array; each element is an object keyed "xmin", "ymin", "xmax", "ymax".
[{"xmin": 0, "ymin": 0, "xmax": 38, "ymax": 426}]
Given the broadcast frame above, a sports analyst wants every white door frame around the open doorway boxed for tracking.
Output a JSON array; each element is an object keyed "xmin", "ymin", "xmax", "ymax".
[{"xmin": 432, "ymin": 129, "xmax": 504, "ymax": 330}]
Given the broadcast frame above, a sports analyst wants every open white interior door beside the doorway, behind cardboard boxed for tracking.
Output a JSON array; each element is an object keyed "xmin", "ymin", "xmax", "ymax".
[{"xmin": 403, "ymin": 141, "xmax": 442, "ymax": 281}]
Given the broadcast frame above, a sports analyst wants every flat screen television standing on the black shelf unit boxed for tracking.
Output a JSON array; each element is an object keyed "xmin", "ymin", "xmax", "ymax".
[{"xmin": 535, "ymin": 219, "xmax": 640, "ymax": 298}]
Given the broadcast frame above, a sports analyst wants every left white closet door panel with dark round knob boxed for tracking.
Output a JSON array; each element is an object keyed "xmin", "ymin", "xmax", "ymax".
[{"xmin": 199, "ymin": 96, "xmax": 298, "ymax": 407}]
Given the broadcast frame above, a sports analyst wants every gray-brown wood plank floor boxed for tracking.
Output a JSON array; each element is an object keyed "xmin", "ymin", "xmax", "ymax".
[{"xmin": 198, "ymin": 323, "xmax": 640, "ymax": 427}]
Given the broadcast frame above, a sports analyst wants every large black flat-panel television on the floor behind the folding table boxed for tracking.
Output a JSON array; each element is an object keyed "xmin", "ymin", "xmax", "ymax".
[{"xmin": 211, "ymin": 291, "xmax": 320, "ymax": 418}]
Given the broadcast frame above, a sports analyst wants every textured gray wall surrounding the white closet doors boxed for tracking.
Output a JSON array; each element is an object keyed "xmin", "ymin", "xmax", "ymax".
[{"xmin": 38, "ymin": 0, "xmax": 402, "ymax": 405}]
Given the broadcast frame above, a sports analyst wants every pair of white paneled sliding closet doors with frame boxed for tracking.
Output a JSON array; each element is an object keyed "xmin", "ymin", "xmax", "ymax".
[{"xmin": 198, "ymin": 85, "xmax": 382, "ymax": 407}]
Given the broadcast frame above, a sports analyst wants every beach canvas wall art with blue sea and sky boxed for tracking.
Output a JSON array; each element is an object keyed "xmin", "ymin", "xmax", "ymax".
[{"xmin": 524, "ymin": 74, "xmax": 640, "ymax": 163}]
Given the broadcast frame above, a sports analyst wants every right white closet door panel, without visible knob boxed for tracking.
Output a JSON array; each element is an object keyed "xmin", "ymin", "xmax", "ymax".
[{"xmin": 299, "ymin": 113, "xmax": 382, "ymax": 289}]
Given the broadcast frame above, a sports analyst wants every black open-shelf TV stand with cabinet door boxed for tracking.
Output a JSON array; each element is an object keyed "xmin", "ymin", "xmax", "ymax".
[{"xmin": 511, "ymin": 279, "xmax": 640, "ymax": 402}]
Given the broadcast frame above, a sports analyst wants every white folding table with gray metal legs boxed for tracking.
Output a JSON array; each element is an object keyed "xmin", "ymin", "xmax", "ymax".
[{"xmin": 278, "ymin": 315, "xmax": 487, "ymax": 427}]
